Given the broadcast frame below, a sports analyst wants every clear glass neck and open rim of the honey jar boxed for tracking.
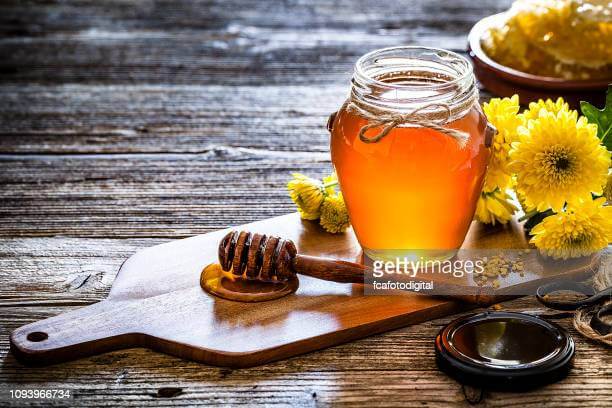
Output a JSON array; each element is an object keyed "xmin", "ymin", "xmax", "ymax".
[{"xmin": 351, "ymin": 47, "xmax": 478, "ymax": 122}]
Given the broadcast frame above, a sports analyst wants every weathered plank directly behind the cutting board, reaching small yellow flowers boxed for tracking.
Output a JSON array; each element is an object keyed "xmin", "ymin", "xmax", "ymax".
[{"xmin": 0, "ymin": 148, "xmax": 331, "ymax": 237}]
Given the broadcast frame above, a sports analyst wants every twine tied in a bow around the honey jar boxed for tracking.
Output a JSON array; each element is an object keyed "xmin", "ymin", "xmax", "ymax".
[{"xmin": 347, "ymin": 96, "xmax": 477, "ymax": 148}]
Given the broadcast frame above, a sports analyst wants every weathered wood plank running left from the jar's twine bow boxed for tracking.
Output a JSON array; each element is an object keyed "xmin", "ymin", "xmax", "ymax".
[{"xmin": 0, "ymin": 85, "xmax": 490, "ymax": 154}]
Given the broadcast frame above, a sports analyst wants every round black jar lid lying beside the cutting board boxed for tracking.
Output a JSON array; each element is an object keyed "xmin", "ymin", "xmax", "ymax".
[{"xmin": 435, "ymin": 312, "xmax": 574, "ymax": 390}]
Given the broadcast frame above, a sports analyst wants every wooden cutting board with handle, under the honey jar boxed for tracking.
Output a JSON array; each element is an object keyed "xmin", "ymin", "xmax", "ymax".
[{"xmin": 11, "ymin": 214, "xmax": 594, "ymax": 367}]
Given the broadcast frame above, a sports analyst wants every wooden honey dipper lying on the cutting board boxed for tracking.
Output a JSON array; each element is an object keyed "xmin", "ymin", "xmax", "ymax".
[{"xmin": 219, "ymin": 231, "xmax": 502, "ymax": 305}]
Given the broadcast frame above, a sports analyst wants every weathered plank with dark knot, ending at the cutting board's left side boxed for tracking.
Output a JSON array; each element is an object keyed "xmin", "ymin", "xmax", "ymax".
[{"xmin": 0, "ymin": 238, "xmax": 166, "ymax": 307}]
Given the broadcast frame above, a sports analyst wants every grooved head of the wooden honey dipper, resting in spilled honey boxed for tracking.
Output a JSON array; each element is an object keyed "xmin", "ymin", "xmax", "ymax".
[{"xmin": 219, "ymin": 231, "xmax": 297, "ymax": 282}]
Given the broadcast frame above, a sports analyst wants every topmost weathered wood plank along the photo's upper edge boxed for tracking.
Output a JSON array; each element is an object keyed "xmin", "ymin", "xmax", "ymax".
[{"xmin": 0, "ymin": 0, "xmax": 512, "ymax": 36}]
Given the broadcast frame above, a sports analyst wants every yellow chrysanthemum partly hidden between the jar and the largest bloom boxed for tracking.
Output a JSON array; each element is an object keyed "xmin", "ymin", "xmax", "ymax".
[{"xmin": 482, "ymin": 95, "xmax": 523, "ymax": 192}]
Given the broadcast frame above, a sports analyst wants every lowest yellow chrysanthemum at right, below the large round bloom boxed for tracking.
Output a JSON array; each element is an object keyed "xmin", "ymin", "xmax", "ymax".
[{"xmin": 530, "ymin": 198, "xmax": 612, "ymax": 259}]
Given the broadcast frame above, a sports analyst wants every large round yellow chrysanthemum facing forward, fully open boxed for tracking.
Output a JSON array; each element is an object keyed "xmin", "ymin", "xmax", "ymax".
[{"xmin": 509, "ymin": 110, "xmax": 610, "ymax": 212}]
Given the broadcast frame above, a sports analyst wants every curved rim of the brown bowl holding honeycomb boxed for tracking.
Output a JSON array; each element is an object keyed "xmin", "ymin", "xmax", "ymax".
[{"xmin": 468, "ymin": 12, "xmax": 612, "ymax": 90}]
